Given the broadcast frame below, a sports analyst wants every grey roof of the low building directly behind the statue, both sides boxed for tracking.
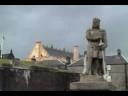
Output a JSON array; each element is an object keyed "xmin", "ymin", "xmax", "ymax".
[{"xmin": 71, "ymin": 55, "xmax": 127, "ymax": 67}]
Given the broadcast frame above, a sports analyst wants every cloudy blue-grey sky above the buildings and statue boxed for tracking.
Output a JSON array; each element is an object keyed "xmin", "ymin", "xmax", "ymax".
[{"xmin": 0, "ymin": 5, "xmax": 128, "ymax": 59}]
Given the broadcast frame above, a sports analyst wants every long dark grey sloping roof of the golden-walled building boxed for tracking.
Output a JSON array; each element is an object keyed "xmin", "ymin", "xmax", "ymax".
[{"xmin": 44, "ymin": 46, "xmax": 73, "ymax": 57}]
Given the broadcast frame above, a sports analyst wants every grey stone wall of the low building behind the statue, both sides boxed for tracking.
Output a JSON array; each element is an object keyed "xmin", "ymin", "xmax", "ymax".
[{"xmin": 68, "ymin": 64, "xmax": 128, "ymax": 90}]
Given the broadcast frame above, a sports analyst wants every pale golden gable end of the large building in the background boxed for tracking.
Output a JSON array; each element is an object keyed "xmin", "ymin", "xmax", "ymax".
[{"xmin": 27, "ymin": 41, "xmax": 48, "ymax": 61}]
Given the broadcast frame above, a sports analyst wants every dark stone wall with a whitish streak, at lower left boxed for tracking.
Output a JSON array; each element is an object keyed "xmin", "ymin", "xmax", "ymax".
[{"xmin": 0, "ymin": 66, "xmax": 79, "ymax": 91}]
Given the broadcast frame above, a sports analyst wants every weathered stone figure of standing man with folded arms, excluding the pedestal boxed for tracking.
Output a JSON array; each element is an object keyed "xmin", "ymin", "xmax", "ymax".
[{"xmin": 85, "ymin": 18, "xmax": 107, "ymax": 76}]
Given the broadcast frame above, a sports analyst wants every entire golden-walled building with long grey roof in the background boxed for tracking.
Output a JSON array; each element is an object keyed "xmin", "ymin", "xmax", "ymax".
[{"xmin": 26, "ymin": 41, "xmax": 81, "ymax": 63}]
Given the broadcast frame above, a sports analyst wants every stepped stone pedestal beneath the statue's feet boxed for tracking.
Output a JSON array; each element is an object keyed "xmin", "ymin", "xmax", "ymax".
[{"xmin": 70, "ymin": 75, "xmax": 114, "ymax": 91}]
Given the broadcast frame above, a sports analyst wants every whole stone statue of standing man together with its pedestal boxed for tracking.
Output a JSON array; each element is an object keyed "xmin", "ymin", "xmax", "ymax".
[{"xmin": 70, "ymin": 18, "xmax": 116, "ymax": 90}]
